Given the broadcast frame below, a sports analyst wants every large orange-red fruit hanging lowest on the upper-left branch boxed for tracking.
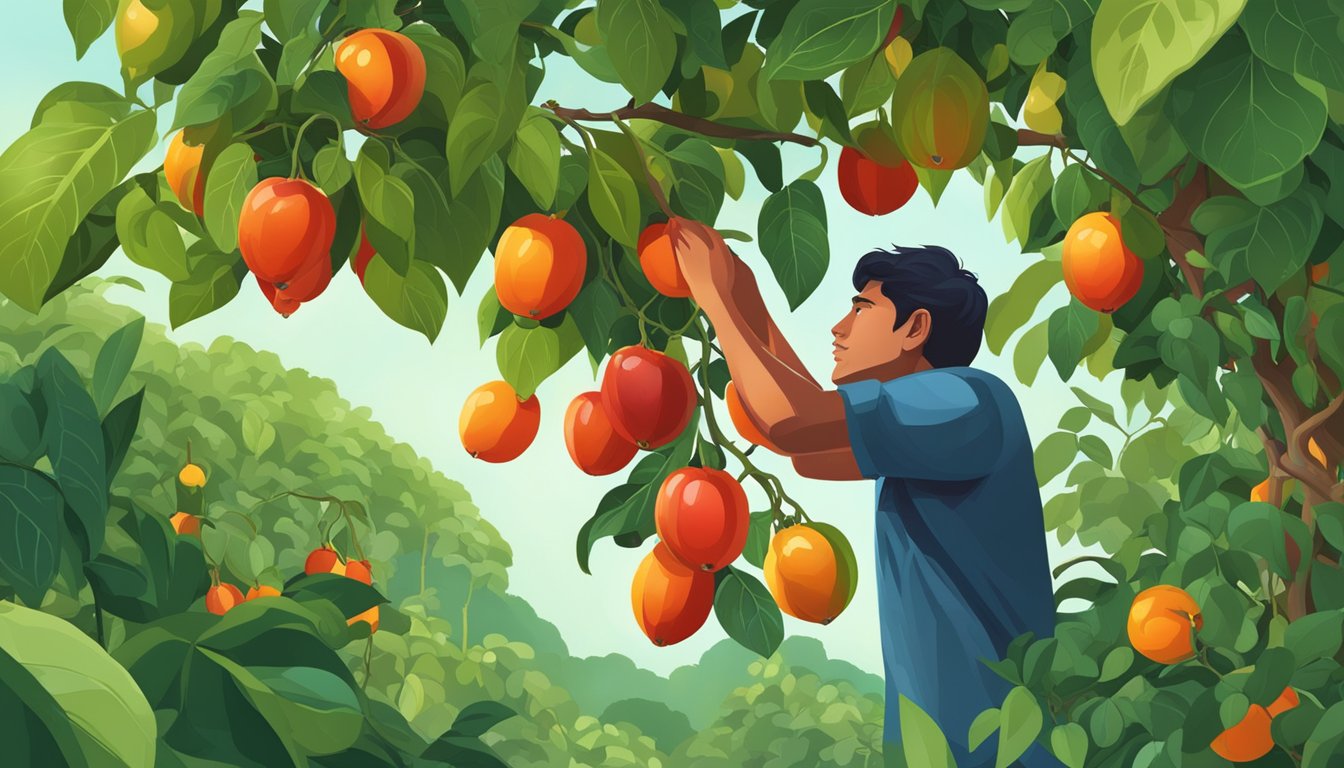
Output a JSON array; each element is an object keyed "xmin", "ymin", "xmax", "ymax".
[{"xmin": 238, "ymin": 176, "xmax": 336, "ymax": 288}]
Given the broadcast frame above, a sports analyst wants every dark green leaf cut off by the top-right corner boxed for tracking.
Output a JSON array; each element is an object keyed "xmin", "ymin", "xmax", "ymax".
[{"xmin": 1241, "ymin": 0, "xmax": 1344, "ymax": 90}]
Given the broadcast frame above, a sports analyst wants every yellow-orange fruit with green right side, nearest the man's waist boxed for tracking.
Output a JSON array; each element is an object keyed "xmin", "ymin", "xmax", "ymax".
[{"xmin": 763, "ymin": 523, "xmax": 857, "ymax": 624}]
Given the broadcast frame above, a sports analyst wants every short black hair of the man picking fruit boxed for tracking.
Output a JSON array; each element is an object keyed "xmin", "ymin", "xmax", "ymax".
[{"xmin": 853, "ymin": 245, "xmax": 989, "ymax": 369}]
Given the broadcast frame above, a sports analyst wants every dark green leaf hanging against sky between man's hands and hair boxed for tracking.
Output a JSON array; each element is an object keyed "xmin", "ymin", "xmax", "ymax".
[{"xmin": 757, "ymin": 179, "xmax": 831, "ymax": 309}]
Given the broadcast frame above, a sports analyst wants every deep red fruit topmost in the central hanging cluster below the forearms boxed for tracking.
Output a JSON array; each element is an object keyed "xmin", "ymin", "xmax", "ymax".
[{"xmin": 602, "ymin": 347, "xmax": 696, "ymax": 451}]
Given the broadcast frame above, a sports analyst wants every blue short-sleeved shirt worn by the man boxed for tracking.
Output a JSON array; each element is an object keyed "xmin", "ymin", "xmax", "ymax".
[{"xmin": 840, "ymin": 367, "xmax": 1059, "ymax": 768}]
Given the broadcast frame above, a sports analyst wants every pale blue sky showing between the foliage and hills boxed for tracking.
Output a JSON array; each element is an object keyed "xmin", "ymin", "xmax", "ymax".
[{"xmin": 0, "ymin": 0, "xmax": 1102, "ymax": 673}]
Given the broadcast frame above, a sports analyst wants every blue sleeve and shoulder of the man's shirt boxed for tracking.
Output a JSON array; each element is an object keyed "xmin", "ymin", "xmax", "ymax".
[{"xmin": 840, "ymin": 371, "xmax": 1004, "ymax": 480}]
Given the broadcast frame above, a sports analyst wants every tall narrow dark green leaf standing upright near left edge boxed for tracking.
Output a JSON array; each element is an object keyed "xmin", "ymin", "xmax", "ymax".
[{"xmin": 38, "ymin": 347, "xmax": 108, "ymax": 560}]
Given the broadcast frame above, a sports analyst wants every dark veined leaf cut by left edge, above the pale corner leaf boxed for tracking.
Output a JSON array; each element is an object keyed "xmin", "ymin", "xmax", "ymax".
[{"xmin": 0, "ymin": 464, "xmax": 65, "ymax": 610}]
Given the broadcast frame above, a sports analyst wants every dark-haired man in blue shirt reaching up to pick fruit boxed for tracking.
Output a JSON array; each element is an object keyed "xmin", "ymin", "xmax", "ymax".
[{"xmin": 668, "ymin": 219, "xmax": 1059, "ymax": 768}]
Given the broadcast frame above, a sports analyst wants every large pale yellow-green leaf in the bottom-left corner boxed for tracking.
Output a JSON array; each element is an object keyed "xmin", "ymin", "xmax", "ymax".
[{"xmin": 0, "ymin": 601, "xmax": 157, "ymax": 765}]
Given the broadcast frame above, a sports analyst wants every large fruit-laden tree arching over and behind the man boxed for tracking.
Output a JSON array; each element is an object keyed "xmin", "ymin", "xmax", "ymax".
[{"xmin": 0, "ymin": 0, "xmax": 1344, "ymax": 765}]
